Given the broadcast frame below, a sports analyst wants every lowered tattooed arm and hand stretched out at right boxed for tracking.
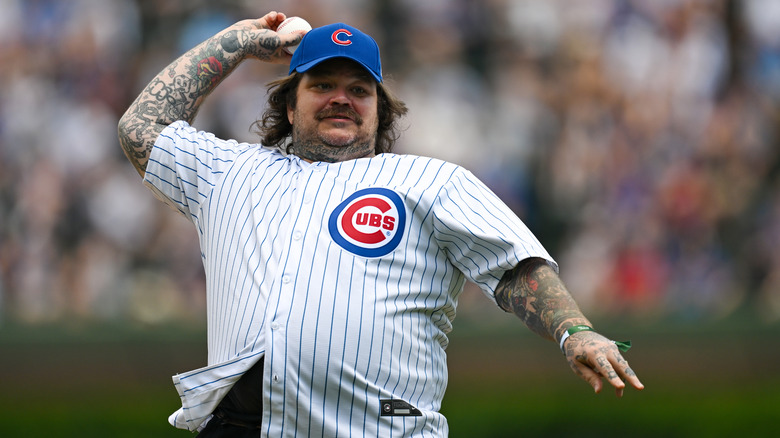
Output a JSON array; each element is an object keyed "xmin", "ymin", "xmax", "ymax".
[{"xmin": 495, "ymin": 257, "xmax": 644, "ymax": 397}]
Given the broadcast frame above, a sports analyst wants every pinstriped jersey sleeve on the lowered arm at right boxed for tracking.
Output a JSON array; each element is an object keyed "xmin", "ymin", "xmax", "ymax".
[{"xmin": 434, "ymin": 169, "xmax": 558, "ymax": 301}]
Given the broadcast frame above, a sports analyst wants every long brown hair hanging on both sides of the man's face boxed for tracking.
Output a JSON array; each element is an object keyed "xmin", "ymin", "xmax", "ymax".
[{"xmin": 252, "ymin": 72, "xmax": 407, "ymax": 154}]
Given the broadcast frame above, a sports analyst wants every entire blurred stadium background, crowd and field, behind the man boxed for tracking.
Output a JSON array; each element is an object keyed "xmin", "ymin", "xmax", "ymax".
[{"xmin": 0, "ymin": 0, "xmax": 780, "ymax": 437}]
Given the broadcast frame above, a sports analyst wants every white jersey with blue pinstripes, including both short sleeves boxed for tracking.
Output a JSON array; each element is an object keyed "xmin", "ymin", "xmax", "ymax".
[{"xmin": 145, "ymin": 121, "xmax": 552, "ymax": 437}]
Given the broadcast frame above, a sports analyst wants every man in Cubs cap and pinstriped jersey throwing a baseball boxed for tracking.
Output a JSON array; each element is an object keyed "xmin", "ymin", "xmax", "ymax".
[{"xmin": 114, "ymin": 12, "xmax": 643, "ymax": 437}]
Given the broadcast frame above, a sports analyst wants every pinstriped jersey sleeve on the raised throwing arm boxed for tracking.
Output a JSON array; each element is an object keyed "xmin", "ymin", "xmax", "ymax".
[{"xmin": 144, "ymin": 121, "xmax": 246, "ymax": 222}]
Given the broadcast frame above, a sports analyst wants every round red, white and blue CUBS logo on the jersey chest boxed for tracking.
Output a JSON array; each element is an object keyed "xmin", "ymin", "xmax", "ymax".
[{"xmin": 328, "ymin": 188, "xmax": 406, "ymax": 257}]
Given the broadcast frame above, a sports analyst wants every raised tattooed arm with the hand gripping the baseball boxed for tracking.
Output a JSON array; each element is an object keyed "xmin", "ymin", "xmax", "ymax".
[{"xmin": 118, "ymin": 12, "xmax": 303, "ymax": 176}]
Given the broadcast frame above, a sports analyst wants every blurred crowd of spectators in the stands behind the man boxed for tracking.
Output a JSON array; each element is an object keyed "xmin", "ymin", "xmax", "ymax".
[{"xmin": 0, "ymin": 0, "xmax": 780, "ymax": 324}]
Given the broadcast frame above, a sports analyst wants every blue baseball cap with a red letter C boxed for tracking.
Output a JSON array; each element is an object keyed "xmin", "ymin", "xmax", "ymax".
[{"xmin": 289, "ymin": 23, "xmax": 382, "ymax": 82}]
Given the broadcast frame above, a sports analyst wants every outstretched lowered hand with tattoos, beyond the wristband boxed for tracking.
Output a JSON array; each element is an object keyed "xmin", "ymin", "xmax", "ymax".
[{"xmin": 564, "ymin": 331, "xmax": 645, "ymax": 397}]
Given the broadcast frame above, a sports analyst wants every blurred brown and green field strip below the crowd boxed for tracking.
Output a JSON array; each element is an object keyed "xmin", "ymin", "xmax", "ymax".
[{"xmin": 0, "ymin": 310, "xmax": 780, "ymax": 438}]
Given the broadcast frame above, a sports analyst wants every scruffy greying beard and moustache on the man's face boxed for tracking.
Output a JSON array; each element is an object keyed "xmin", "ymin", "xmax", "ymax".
[{"xmin": 291, "ymin": 108, "xmax": 377, "ymax": 163}]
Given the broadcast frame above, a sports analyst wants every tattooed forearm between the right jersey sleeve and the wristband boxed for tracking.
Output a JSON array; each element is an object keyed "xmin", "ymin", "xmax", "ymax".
[{"xmin": 495, "ymin": 257, "xmax": 590, "ymax": 341}]
